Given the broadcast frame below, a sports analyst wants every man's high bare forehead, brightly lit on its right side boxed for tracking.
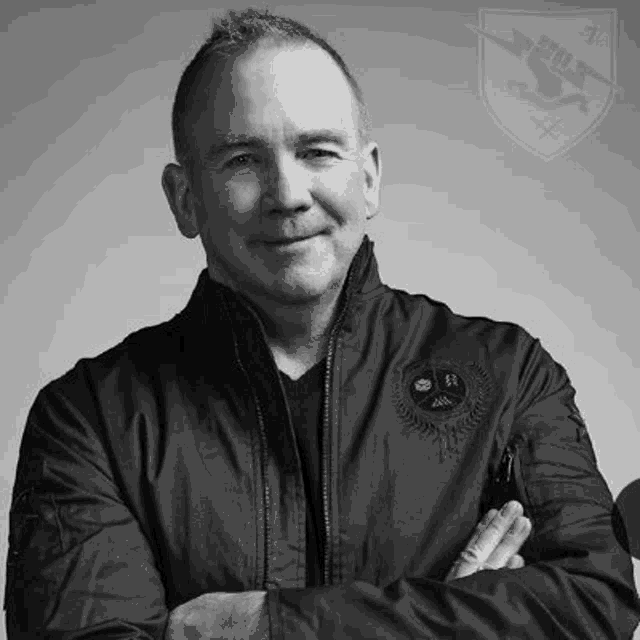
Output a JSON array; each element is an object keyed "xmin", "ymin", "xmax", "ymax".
[{"xmin": 191, "ymin": 43, "xmax": 358, "ymax": 147}]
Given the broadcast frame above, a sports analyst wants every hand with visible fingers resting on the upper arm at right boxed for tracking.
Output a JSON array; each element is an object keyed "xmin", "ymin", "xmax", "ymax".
[{"xmin": 445, "ymin": 500, "xmax": 531, "ymax": 582}]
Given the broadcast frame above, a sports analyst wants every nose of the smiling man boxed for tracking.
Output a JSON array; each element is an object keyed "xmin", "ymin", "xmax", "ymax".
[{"xmin": 263, "ymin": 157, "xmax": 313, "ymax": 214}]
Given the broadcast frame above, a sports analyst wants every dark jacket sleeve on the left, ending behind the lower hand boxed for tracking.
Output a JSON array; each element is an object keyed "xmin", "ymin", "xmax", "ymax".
[{"xmin": 4, "ymin": 376, "xmax": 167, "ymax": 640}]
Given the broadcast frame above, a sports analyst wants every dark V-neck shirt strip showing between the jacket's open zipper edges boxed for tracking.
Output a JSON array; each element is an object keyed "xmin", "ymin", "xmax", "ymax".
[{"xmin": 280, "ymin": 359, "xmax": 325, "ymax": 586}]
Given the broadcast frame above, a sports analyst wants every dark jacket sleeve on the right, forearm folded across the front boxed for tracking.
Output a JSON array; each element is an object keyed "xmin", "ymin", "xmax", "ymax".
[{"xmin": 268, "ymin": 338, "xmax": 640, "ymax": 640}]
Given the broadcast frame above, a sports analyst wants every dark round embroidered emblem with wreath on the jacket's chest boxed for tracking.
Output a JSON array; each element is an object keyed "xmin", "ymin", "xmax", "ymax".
[{"xmin": 392, "ymin": 358, "xmax": 493, "ymax": 460}]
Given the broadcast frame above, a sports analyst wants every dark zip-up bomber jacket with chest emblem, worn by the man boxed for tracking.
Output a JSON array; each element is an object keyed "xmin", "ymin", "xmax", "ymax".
[{"xmin": 5, "ymin": 236, "xmax": 640, "ymax": 640}]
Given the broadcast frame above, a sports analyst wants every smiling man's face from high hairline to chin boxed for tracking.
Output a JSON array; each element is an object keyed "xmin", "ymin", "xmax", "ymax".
[{"xmin": 169, "ymin": 44, "xmax": 379, "ymax": 302}]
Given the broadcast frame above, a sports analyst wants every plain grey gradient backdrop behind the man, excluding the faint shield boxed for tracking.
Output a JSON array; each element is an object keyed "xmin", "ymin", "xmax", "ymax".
[{"xmin": 0, "ymin": 0, "xmax": 640, "ymax": 638}]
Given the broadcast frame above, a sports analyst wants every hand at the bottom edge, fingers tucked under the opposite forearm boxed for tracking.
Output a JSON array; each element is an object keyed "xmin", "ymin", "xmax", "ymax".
[{"xmin": 164, "ymin": 591, "xmax": 268, "ymax": 640}]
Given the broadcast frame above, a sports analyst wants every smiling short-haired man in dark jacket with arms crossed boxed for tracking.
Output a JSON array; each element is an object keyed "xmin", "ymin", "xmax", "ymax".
[{"xmin": 5, "ymin": 10, "xmax": 640, "ymax": 640}]
